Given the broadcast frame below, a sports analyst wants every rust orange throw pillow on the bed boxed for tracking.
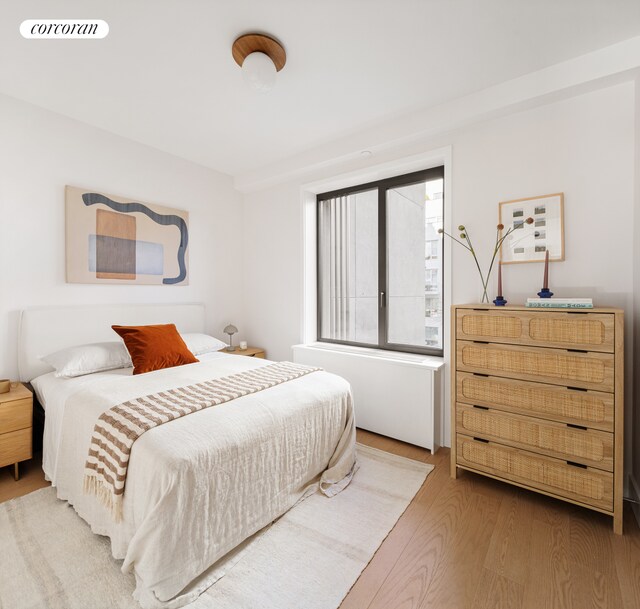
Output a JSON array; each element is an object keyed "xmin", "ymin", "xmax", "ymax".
[{"xmin": 111, "ymin": 324, "xmax": 199, "ymax": 374}]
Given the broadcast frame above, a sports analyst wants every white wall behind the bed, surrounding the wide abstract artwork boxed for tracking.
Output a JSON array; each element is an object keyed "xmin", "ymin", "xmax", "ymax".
[{"xmin": 0, "ymin": 96, "xmax": 244, "ymax": 378}]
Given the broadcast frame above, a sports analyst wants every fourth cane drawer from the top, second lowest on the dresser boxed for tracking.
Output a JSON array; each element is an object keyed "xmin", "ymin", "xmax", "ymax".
[{"xmin": 456, "ymin": 404, "xmax": 613, "ymax": 472}]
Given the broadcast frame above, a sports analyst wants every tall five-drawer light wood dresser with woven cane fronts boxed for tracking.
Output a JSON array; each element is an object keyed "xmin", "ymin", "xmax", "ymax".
[{"xmin": 451, "ymin": 305, "xmax": 624, "ymax": 533}]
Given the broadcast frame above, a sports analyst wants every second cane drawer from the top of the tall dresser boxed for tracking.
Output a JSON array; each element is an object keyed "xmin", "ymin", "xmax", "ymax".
[{"xmin": 456, "ymin": 340, "xmax": 614, "ymax": 392}]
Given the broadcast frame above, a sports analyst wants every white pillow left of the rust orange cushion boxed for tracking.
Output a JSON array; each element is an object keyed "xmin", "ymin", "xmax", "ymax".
[{"xmin": 40, "ymin": 341, "xmax": 133, "ymax": 378}]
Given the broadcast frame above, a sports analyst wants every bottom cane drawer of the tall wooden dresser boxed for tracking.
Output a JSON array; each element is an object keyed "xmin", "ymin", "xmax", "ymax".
[{"xmin": 457, "ymin": 434, "xmax": 613, "ymax": 512}]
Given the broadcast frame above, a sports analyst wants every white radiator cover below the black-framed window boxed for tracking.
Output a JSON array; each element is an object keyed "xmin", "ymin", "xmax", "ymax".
[{"xmin": 293, "ymin": 343, "xmax": 444, "ymax": 452}]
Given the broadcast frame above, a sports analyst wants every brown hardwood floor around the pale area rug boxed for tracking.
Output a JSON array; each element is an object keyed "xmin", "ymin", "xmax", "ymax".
[{"xmin": 0, "ymin": 430, "xmax": 640, "ymax": 609}]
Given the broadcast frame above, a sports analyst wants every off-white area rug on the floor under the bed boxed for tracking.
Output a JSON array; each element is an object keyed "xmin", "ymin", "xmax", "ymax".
[{"xmin": 0, "ymin": 445, "xmax": 433, "ymax": 609}]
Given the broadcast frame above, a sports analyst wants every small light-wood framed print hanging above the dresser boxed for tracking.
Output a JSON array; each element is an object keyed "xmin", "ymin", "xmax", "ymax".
[{"xmin": 498, "ymin": 193, "xmax": 564, "ymax": 264}]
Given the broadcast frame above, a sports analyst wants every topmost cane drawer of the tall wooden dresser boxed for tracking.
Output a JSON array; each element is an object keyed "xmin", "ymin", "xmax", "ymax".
[{"xmin": 456, "ymin": 309, "xmax": 614, "ymax": 353}]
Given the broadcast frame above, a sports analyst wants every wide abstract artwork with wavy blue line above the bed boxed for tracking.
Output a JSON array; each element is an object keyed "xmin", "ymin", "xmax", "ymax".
[{"xmin": 65, "ymin": 186, "xmax": 189, "ymax": 285}]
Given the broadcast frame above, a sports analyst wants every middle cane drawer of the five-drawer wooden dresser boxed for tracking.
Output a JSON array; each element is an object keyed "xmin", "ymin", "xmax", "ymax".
[{"xmin": 456, "ymin": 372, "xmax": 614, "ymax": 432}]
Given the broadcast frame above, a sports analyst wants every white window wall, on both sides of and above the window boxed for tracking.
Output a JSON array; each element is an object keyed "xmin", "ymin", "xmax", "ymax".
[{"xmin": 244, "ymin": 83, "xmax": 634, "ymax": 460}]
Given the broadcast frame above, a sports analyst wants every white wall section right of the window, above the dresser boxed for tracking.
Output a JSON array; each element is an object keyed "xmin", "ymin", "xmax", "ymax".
[{"xmin": 453, "ymin": 83, "xmax": 634, "ymax": 310}]
